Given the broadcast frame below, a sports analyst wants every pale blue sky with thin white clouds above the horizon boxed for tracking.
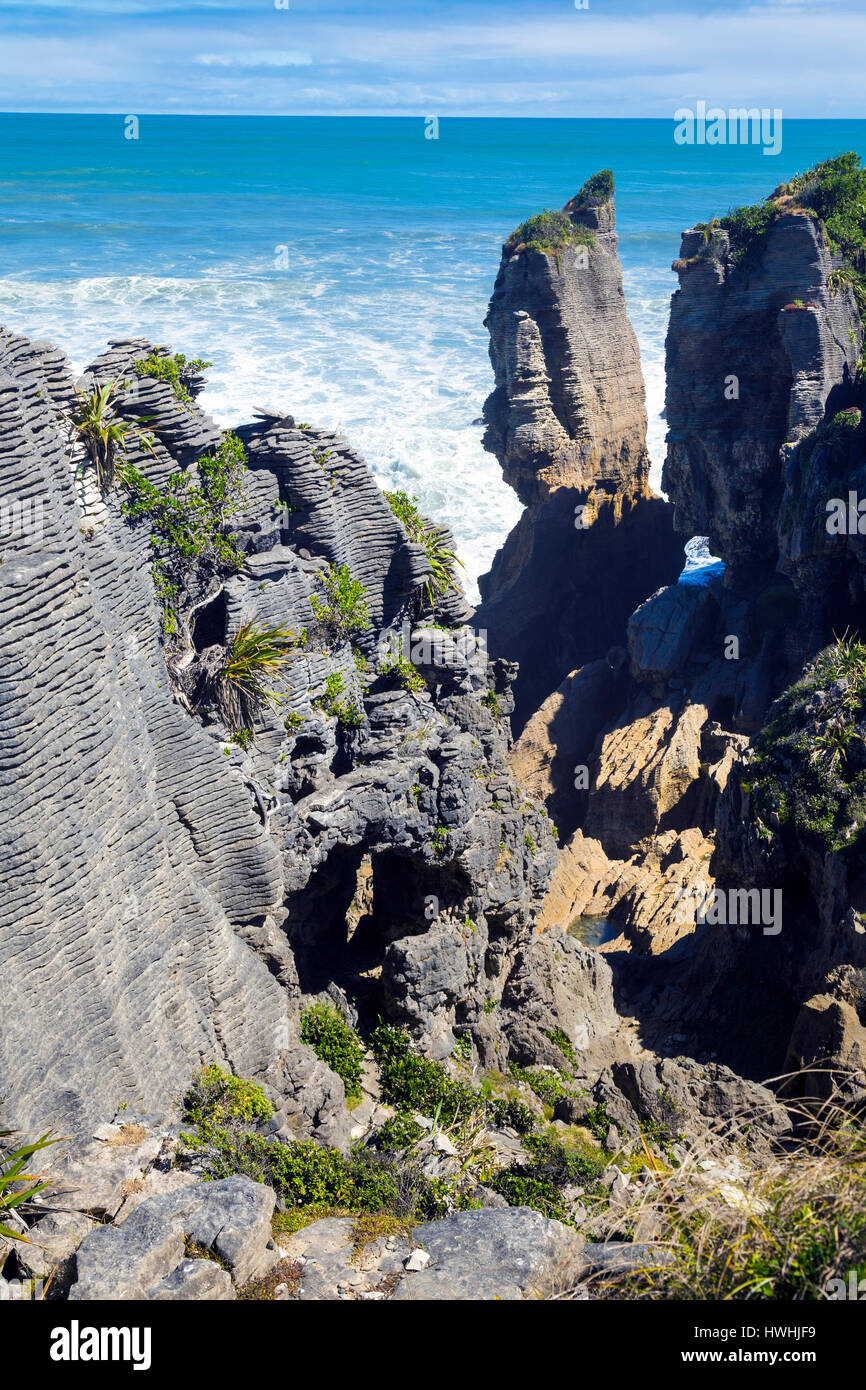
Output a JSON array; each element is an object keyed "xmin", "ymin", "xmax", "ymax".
[{"xmin": 0, "ymin": 0, "xmax": 866, "ymax": 118}]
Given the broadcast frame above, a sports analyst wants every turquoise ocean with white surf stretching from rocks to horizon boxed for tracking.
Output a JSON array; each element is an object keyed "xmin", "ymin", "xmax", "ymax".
[{"xmin": 0, "ymin": 114, "xmax": 866, "ymax": 594}]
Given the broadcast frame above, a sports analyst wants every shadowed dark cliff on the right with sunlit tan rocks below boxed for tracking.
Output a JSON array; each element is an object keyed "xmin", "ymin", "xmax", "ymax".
[{"xmin": 494, "ymin": 162, "xmax": 866, "ymax": 1076}]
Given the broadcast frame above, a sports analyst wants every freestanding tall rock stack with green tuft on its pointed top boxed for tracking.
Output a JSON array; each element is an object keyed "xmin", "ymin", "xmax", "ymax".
[{"xmin": 478, "ymin": 173, "xmax": 683, "ymax": 731}]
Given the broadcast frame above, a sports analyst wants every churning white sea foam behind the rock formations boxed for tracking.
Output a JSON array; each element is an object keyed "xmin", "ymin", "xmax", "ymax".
[{"xmin": 0, "ymin": 259, "xmax": 667, "ymax": 599}]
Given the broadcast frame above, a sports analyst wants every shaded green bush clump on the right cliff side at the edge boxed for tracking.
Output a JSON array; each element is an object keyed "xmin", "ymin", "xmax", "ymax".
[{"xmin": 742, "ymin": 638, "xmax": 866, "ymax": 852}]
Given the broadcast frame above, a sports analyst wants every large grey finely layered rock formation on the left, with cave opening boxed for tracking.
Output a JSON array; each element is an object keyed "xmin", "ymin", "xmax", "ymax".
[{"xmin": 0, "ymin": 334, "xmax": 555, "ymax": 1143}]
